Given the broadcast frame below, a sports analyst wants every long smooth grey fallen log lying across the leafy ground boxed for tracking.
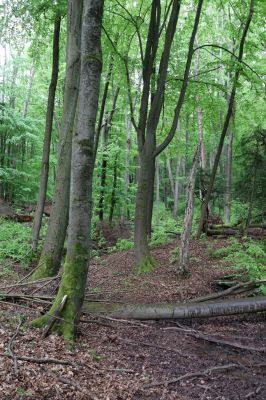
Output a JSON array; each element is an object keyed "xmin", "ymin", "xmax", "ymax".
[{"xmin": 82, "ymin": 296, "xmax": 266, "ymax": 320}]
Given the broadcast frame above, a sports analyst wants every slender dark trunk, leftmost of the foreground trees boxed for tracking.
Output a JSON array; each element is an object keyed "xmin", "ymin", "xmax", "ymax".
[{"xmin": 32, "ymin": 16, "xmax": 61, "ymax": 251}]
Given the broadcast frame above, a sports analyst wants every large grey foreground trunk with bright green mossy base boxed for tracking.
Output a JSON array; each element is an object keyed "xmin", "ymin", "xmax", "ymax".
[{"xmin": 33, "ymin": 0, "xmax": 104, "ymax": 340}]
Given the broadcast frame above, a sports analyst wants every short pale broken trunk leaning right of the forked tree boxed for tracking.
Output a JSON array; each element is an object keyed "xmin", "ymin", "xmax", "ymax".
[{"xmin": 179, "ymin": 144, "xmax": 201, "ymax": 275}]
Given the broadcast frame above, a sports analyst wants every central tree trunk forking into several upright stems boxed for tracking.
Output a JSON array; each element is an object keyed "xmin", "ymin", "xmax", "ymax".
[{"xmin": 134, "ymin": 0, "xmax": 203, "ymax": 270}]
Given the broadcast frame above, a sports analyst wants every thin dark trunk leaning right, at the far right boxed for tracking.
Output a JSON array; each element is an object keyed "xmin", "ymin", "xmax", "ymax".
[{"xmin": 197, "ymin": 0, "xmax": 254, "ymax": 238}]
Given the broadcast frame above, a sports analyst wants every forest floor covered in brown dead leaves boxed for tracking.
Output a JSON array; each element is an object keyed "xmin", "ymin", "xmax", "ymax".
[{"xmin": 0, "ymin": 239, "xmax": 266, "ymax": 400}]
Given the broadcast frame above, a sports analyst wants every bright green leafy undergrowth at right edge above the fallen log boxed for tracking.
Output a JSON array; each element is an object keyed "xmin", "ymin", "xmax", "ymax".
[{"xmin": 208, "ymin": 238, "xmax": 266, "ymax": 295}]
